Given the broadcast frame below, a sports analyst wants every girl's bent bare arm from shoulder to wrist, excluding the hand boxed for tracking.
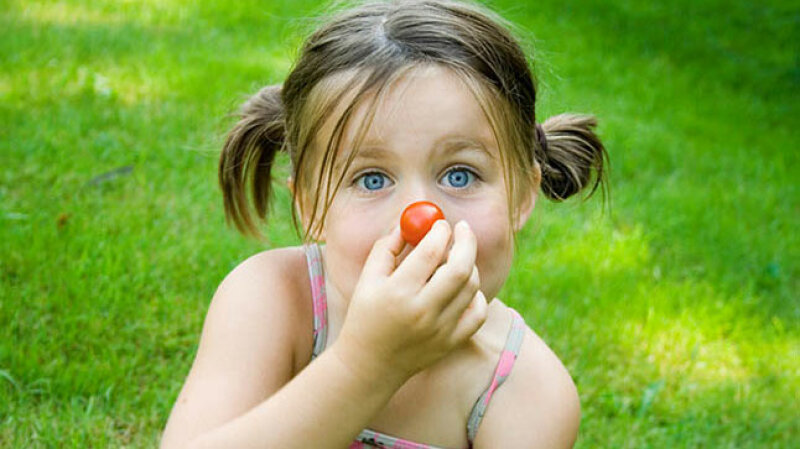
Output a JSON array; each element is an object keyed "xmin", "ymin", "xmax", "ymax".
[{"xmin": 161, "ymin": 250, "xmax": 412, "ymax": 449}]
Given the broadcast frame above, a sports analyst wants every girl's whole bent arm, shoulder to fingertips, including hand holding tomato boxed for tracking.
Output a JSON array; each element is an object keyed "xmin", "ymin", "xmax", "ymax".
[{"xmin": 161, "ymin": 220, "xmax": 486, "ymax": 449}]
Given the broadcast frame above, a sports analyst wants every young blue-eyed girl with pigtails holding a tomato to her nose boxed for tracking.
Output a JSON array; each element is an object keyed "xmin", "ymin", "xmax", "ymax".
[{"xmin": 161, "ymin": 0, "xmax": 607, "ymax": 449}]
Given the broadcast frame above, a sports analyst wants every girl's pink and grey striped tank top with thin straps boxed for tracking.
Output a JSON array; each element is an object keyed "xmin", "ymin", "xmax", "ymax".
[{"xmin": 303, "ymin": 243, "xmax": 525, "ymax": 449}]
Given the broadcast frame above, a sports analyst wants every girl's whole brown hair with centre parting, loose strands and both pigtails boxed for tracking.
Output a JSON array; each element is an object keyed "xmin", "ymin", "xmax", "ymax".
[{"xmin": 219, "ymin": 0, "xmax": 608, "ymax": 240}]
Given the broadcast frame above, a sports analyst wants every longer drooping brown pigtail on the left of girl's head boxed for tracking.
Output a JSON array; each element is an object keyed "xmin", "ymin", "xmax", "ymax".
[{"xmin": 219, "ymin": 85, "xmax": 286, "ymax": 238}]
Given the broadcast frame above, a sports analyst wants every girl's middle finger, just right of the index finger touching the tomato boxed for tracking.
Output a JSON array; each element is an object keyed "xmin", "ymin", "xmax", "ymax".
[{"xmin": 421, "ymin": 221, "xmax": 478, "ymax": 311}]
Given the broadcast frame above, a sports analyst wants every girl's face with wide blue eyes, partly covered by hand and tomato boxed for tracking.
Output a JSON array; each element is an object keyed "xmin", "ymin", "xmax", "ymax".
[{"xmin": 312, "ymin": 66, "xmax": 535, "ymax": 301}]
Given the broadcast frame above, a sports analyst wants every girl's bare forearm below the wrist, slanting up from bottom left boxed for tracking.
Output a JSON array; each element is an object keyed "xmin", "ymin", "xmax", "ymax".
[{"xmin": 188, "ymin": 344, "xmax": 405, "ymax": 449}]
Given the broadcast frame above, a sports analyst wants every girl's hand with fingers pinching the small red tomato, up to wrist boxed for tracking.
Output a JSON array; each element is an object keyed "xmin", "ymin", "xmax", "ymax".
[{"xmin": 332, "ymin": 220, "xmax": 487, "ymax": 377}]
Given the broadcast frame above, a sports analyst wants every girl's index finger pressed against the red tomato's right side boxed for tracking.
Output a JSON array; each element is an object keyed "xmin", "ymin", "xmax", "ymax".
[{"xmin": 394, "ymin": 220, "xmax": 451, "ymax": 287}]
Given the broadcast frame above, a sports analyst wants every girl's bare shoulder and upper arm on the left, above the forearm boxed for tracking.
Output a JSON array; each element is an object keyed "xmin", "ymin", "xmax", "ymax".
[{"xmin": 162, "ymin": 248, "xmax": 310, "ymax": 446}]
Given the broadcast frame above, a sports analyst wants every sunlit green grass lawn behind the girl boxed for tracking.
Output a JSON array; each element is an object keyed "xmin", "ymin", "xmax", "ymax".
[{"xmin": 0, "ymin": 0, "xmax": 800, "ymax": 448}]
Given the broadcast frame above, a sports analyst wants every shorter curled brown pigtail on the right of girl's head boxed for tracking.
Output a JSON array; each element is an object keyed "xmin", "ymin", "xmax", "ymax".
[{"xmin": 536, "ymin": 114, "xmax": 609, "ymax": 201}]
